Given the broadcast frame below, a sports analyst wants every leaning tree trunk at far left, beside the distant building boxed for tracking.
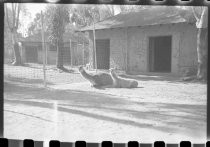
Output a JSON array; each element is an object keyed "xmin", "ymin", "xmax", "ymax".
[{"xmin": 12, "ymin": 33, "xmax": 21, "ymax": 66}]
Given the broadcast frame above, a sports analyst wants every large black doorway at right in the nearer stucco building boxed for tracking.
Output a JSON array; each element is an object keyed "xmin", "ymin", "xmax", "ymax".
[{"xmin": 149, "ymin": 36, "xmax": 172, "ymax": 72}]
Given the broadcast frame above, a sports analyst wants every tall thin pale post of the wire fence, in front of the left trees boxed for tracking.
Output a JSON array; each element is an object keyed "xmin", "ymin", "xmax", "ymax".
[{"xmin": 41, "ymin": 11, "xmax": 47, "ymax": 88}]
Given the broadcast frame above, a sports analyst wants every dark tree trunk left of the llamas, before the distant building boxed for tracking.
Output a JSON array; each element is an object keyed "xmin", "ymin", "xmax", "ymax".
[{"xmin": 56, "ymin": 40, "xmax": 64, "ymax": 69}]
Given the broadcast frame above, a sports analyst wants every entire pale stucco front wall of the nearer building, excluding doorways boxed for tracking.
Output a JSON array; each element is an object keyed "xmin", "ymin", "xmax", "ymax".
[{"xmin": 90, "ymin": 23, "xmax": 197, "ymax": 74}]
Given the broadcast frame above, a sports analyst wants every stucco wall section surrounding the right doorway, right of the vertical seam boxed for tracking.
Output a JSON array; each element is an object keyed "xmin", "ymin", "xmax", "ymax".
[{"xmin": 128, "ymin": 24, "xmax": 197, "ymax": 73}]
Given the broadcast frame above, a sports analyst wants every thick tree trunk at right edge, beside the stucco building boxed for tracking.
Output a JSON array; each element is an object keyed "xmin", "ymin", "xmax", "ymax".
[{"xmin": 197, "ymin": 28, "xmax": 208, "ymax": 80}]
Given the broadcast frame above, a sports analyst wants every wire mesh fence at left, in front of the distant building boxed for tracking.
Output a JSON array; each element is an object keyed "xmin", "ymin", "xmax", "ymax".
[{"xmin": 4, "ymin": 41, "xmax": 90, "ymax": 85}]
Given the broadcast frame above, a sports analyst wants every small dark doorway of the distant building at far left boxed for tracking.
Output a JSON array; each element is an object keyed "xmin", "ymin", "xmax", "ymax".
[{"xmin": 25, "ymin": 46, "xmax": 38, "ymax": 63}]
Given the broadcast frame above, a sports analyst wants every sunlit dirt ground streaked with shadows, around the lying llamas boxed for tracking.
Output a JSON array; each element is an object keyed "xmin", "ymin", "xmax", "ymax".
[{"xmin": 4, "ymin": 65, "xmax": 207, "ymax": 143}]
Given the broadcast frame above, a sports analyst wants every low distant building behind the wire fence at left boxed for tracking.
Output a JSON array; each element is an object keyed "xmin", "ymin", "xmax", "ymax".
[{"xmin": 21, "ymin": 33, "xmax": 88, "ymax": 65}]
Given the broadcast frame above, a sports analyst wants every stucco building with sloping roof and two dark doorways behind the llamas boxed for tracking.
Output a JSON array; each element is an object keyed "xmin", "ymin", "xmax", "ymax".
[{"xmin": 80, "ymin": 6, "xmax": 200, "ymax": 74}]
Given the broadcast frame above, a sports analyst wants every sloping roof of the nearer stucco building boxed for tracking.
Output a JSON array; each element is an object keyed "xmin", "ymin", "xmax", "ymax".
[{"xmin": 80, "ymin": 6, "xmax": 194, "ymax": 31}]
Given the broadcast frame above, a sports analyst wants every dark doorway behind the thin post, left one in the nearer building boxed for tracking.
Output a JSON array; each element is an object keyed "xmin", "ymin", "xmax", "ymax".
[{"xmin": 96, "ymin": 39, "xmax": 110, "ymax": 69}]
